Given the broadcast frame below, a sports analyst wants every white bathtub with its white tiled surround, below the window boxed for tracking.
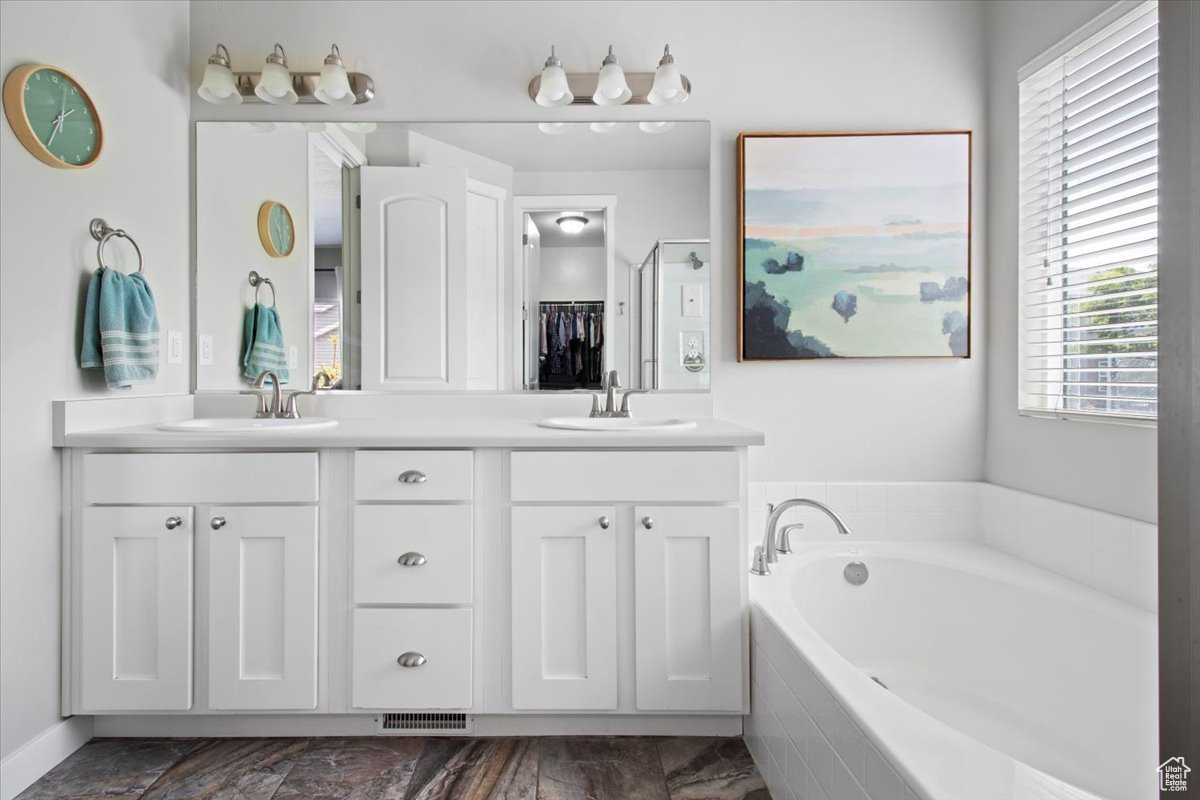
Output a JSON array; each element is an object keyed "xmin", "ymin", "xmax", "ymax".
[{"xmin": 746, "ymin": 483, "xmax": 1156, "ymax": 800}]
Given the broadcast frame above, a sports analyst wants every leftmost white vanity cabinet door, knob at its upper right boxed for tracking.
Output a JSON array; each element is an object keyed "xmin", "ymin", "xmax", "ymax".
[{"xmin": 79, "ymin": 506, "xmax": 192, "ymax": 712}]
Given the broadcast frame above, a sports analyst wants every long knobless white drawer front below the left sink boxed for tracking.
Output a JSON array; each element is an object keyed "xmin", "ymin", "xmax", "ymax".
[{"xmin": 83, "ymin": 452, "xmax": 318, "ymax": 505}]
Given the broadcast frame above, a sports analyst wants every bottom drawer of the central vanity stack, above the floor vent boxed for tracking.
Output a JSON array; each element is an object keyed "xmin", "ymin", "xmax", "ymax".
[{"xmin": 352, "ymin": 608, "xmax": 472, "ymax": 709}]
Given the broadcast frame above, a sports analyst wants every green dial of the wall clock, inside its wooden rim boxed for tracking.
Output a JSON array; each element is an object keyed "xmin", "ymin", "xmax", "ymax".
[{"xmin": 23, "ymin": 68, "xmax": 100, "ymax": 166}]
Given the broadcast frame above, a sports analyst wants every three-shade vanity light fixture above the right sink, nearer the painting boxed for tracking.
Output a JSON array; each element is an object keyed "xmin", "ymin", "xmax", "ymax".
[{"xmin": 529, "ymin": 44, "xmax": 691, "ymax": 108}]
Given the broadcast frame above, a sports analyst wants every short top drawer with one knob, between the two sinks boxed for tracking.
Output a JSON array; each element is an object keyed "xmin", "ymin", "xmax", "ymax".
[{"xmin": 354, "ymin": 450, "xmax": 474, "ymax": 503}]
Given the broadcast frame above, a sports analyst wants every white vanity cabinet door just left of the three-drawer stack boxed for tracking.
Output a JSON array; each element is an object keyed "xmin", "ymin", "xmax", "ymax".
[{"xmin": 200, "ymin": 506, "xmax": 317, "ymax": 710}]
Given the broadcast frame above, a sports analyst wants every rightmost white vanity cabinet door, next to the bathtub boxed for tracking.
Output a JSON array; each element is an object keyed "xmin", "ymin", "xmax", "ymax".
[{"xmin": 634, "ymin": 506, "xmax": 744, "ymax": 711}]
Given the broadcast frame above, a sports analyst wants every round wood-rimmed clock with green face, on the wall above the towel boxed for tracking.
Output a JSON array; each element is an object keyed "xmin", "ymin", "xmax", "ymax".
[{"xmin": 4, "ymin": 64, "xmax": 104, "ymax": 169}]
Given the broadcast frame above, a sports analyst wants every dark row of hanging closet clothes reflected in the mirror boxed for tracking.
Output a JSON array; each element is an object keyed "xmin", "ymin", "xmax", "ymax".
[{"xmin": 538, "ymin": 300, "xmax": 605, "ymax": 389}]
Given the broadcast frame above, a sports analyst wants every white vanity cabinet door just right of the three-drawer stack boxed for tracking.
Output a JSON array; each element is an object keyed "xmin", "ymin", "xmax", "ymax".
[{"xmin": 511, "ymin": 506, "xmax": 617, "ymax": 710}]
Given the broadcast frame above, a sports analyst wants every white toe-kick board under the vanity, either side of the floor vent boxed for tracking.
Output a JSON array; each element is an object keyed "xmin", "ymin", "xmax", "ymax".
[{"xmin": 95, "ymin": 714, "xmax": 742, "ymax": 738}]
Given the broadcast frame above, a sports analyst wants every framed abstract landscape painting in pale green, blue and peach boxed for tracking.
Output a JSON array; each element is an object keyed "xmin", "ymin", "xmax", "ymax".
[{"xmin": 738, "ymin": 131, "xmax": 971, "ymax": 361}]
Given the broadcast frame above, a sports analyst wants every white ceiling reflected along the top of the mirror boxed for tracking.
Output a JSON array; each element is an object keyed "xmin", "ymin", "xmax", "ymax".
[{"xmin": 367, "ymin": 121, "xmax": 710, "ymax": 173}]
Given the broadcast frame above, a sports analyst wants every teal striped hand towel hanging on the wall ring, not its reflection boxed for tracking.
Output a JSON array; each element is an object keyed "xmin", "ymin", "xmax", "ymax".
[{"xmin": 79, "ymin": 267, "xmax": 158, "ymax": 389}]
